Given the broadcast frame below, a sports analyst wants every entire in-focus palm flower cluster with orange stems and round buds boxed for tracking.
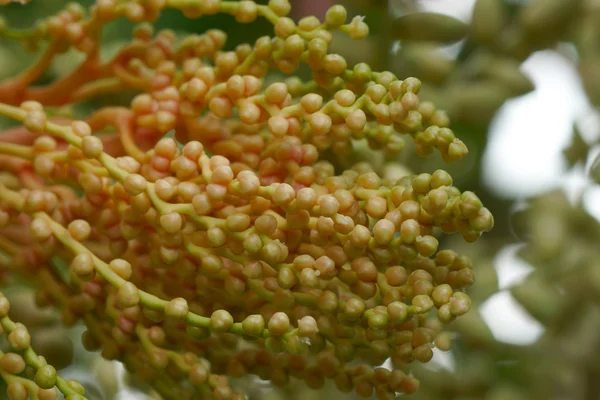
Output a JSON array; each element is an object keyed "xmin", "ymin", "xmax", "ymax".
[{"xmin": 0, "ymin": 0, "xmax": 493, "ymax": 400}]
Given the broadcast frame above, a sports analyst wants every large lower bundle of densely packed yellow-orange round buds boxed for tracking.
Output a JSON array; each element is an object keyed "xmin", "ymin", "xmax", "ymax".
[{"xmin": 0, "ymin": 123, "xmax": 493, "ymax": 393}]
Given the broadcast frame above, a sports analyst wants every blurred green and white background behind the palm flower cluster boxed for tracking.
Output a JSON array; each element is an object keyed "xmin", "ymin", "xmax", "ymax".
[{"xmin": 0, "ymin": 0, "xmax": 600, "ymax": 400}]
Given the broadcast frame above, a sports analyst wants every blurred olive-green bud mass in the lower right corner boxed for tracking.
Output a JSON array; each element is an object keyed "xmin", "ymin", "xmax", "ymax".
[{"xmin": 398, "ymin": 186, "xmax": 600, "ymax": 400}]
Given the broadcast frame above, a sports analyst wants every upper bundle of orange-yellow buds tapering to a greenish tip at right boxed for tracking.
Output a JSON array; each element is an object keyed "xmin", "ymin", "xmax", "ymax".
[{"xmin": 116, "ymin": 24, "xmax": 467, "ymax": 167}]
